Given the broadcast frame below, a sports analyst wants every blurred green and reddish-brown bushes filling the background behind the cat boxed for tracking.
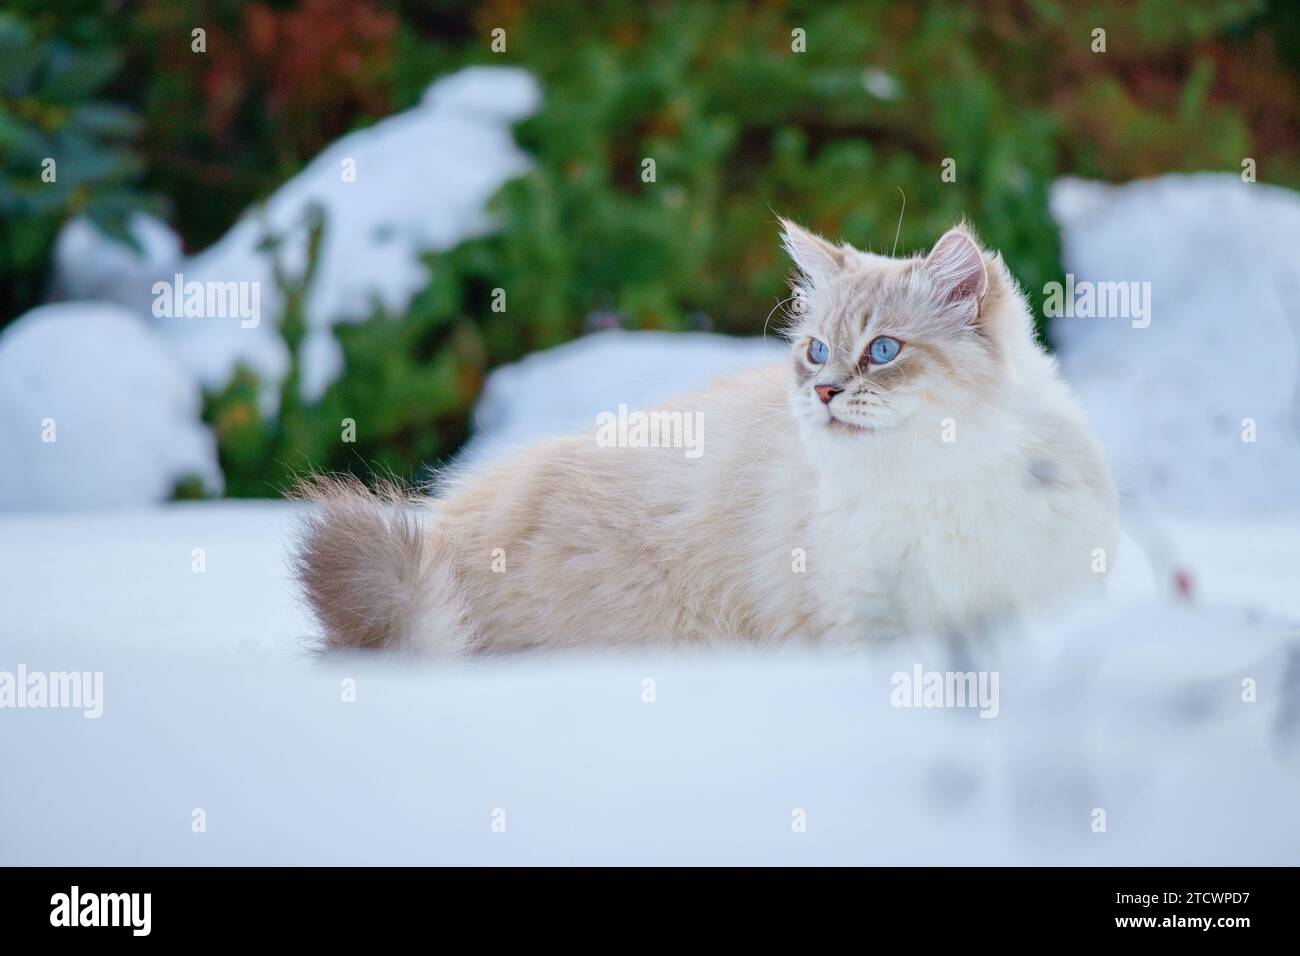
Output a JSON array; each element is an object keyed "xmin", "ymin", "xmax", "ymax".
[{"xmin": 0, "ymin": 0, "xmax": 1300, "ymax": 494}]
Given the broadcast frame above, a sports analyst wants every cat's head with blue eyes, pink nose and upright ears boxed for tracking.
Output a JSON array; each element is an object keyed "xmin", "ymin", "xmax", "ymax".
[{"xmin": 784, "ymin": 222, "xmax": 1002, "ymax": 440}]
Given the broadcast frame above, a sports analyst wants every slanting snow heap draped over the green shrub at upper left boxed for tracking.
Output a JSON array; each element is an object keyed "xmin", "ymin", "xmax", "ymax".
[{"xmin": 48, "ymin": 66, "xmax": 540, "ymax": 401}]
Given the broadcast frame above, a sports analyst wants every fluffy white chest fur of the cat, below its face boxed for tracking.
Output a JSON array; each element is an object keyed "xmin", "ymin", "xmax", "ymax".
[{"xmin": 802, "ymin": 361, "xmax": 1118, "ymax": 637}]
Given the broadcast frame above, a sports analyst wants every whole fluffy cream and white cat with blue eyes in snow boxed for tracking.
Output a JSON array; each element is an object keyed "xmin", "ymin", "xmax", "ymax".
[{"xmin": 298, "ymin": 222, "xmax": 1118, "ymax": 654}]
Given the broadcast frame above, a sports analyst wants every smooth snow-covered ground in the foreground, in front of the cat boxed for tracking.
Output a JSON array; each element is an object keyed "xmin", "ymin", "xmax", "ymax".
[{"xmin": 0, "ymin": 502, "xmax": 1300, "ymax": 865}]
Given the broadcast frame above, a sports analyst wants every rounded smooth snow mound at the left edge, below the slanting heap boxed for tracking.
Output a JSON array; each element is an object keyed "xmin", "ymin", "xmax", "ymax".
[{"xmin": 0, "ymin": 302, "xmax": 221, "ymax": 510}]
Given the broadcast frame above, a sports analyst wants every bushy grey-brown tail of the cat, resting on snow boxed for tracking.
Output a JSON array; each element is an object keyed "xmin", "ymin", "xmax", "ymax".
[{"xmin": 294, "ymin": 476, "xmax": 473, "ymax": 656}]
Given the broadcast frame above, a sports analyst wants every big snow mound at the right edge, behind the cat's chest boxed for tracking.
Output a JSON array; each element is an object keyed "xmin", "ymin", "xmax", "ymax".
[{"xmin": 1050, "ymin": 173, "xmax": 1300, "ymax": 514}]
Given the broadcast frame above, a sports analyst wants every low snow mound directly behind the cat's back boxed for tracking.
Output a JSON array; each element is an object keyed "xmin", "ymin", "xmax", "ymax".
[{"xmin": 464, "ymin": 329, "xmax": 787, "ymax": 463}]
